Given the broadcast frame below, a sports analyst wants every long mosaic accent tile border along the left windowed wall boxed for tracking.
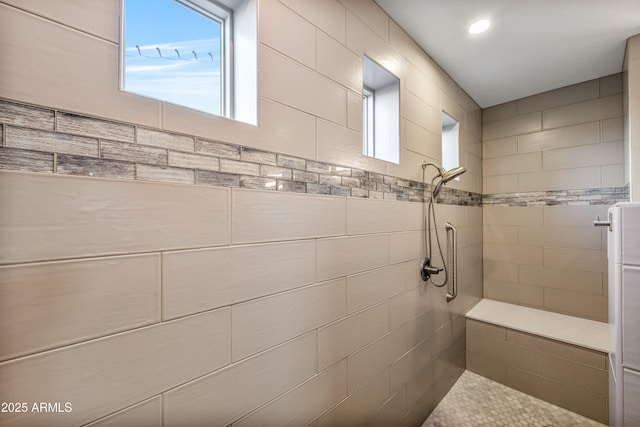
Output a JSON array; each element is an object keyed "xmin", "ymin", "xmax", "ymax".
[{"xmin": 0, "ymin": 100, "xmax": 482, "ymax": 206}]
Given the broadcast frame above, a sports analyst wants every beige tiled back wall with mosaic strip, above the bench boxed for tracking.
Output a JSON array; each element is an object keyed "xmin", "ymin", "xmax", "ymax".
[{"xmin": 483, "ymin": 74, "xmax": 628, "ymax": 321}]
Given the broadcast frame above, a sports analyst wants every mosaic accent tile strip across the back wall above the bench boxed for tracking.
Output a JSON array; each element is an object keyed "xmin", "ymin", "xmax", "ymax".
[{"xmin": 482, "ymin": 184, "xmax": 630, "ymax": 206}]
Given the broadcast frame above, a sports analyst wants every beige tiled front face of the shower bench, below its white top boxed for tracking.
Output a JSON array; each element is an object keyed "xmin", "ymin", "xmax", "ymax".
[{"xmin": 467, "ymin": 319, "xmax": 609, "ymax": 423}]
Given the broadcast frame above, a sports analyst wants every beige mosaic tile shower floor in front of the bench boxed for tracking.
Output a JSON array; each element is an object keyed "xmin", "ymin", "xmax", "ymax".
[{"xmin": 422, "ymin": 371, "xmax": 604, "ymax": 427}]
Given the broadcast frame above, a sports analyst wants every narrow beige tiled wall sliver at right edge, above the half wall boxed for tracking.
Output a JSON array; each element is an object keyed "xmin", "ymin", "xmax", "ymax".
[{"xmin": 623, "ymin": 35, "xmax": 640, "ymax": 202}]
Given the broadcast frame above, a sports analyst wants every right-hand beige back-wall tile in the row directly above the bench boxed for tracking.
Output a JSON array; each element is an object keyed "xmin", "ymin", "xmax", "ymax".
[{"xmin": 544, "ymin": 288, "xmax": 608, "ymax": 322}]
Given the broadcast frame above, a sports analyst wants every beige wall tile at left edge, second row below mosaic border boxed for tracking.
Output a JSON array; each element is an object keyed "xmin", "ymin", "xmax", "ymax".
[{"xmin": 0, "ymin": 254, "xmax": 160, "ymax": 360}]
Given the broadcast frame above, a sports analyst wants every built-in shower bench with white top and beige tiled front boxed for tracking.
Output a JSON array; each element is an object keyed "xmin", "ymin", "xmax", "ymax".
[{"xmin": 466, "ymin": 299, "xmax": 609, "ymax": 423}]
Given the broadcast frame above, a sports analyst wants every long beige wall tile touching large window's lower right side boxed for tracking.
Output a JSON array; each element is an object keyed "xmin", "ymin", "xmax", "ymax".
[{"xmin": 259, "ymin": 46, "xmax": 347, "ymax": 126}]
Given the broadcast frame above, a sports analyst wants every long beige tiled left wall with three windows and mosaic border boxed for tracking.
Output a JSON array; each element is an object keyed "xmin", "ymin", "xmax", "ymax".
[{"xmin": 0, "ymin": 0, "xmax": 482, "ymax": 426}]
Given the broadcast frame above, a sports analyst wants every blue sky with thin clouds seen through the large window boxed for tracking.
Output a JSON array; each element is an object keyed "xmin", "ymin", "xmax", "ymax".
[{"xmin": 124, "ymin": 0, "xmax": 223, "ymax": 115}]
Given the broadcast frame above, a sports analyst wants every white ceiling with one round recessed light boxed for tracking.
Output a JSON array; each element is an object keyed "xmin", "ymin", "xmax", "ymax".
[{"xmin": 375, "ymin": 0, "xmax": 640, "ymax": 108}]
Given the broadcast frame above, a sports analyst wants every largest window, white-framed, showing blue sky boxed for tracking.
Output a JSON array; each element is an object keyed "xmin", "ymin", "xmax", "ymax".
[{"xmin": 121, "ymin": 0, "xmax": 257, "ymax": 124}]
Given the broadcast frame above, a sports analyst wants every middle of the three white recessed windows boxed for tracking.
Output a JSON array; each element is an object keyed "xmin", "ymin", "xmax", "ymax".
[{"xmin": 362, "ymin": 56, "xmax": 400, "ymax": 163}]
